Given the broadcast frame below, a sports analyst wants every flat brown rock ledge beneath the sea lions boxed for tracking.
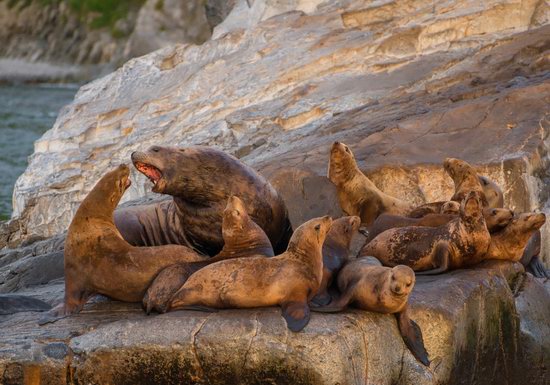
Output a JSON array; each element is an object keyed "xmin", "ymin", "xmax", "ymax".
[{"xmin": 0, "ymin": 262, "xmax": 550, "ymax": 385}]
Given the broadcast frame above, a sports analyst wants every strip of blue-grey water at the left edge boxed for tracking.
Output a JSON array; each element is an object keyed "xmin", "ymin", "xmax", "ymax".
[{"xmin": 0, "ymin": 84, "xmax": 78, "ymax": 220}]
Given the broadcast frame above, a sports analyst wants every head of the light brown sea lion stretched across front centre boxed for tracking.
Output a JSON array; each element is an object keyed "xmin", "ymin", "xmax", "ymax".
[{"xmin": 287, "ymin": 215, "xmax": 332, "ymax": 254}]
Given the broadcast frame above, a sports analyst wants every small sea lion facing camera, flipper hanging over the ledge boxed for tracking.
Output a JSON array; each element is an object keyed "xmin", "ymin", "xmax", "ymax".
[{"xmin": 313, "ymin": 257, "xmax": 430, "ymax": 366}]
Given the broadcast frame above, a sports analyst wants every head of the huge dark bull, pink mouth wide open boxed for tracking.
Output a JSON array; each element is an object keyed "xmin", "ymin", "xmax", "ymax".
[{"xmin": 132, "ymin": 146, "xmax": 232, "ymax": 204}]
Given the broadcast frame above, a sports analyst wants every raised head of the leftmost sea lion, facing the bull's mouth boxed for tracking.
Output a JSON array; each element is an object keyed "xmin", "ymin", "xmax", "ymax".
[{"xmin": 82, "ymin": 164, "xmax": 132, "ymax": 214}]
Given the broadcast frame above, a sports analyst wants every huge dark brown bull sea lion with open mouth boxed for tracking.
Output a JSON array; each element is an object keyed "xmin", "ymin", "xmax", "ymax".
[{"xmin": 115, "ymin": 146, "xmax": 292, "ymax": 256}]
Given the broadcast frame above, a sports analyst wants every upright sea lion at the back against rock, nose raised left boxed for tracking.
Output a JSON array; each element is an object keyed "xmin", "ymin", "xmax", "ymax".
[{"xmin": 327, "ymin": 142, "xmax": 413, "ymax": 226}]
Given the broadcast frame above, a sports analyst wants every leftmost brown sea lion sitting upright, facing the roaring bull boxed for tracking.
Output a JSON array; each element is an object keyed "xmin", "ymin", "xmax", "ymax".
[{"xmin": 38, "ymin": 165, "xmax": 205, "ymax": 323}]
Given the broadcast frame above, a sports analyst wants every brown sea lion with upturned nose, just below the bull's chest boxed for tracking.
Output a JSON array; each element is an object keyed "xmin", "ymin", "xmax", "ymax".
[{"xmin": 143, "ymin": 196, "xmax": 274, "ymax": 314}]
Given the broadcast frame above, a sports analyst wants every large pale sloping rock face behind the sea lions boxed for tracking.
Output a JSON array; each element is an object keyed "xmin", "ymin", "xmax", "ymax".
[{"xmin": 5, "ymin": 0, "xmax": 550, "ymax": 264}]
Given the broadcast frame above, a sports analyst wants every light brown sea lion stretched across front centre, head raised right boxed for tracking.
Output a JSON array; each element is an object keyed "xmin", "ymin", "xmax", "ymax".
[{"xmin": 170, "ymin": 216, "xmax": 332, "ymax": 332}]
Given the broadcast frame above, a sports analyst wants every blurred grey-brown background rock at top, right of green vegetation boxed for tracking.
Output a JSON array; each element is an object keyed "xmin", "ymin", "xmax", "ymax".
[{"xmin": 124, "ymin": 0, "xmax": 211, "ymax": 58}]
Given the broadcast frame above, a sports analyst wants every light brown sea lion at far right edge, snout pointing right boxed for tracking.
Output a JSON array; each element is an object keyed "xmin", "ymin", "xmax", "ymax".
[{"xmin": 484, "ymin": 213, "xmax": 546, "ymax": 262}]
